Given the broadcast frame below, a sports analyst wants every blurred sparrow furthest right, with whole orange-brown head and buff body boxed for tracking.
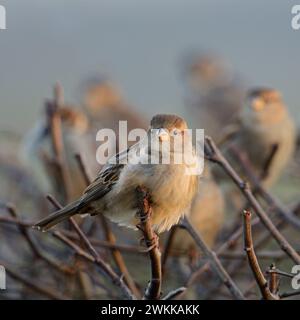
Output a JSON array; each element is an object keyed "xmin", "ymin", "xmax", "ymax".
[{"xmin": 233, "ymin": 88, "xmax": 296, "ymax": 187}]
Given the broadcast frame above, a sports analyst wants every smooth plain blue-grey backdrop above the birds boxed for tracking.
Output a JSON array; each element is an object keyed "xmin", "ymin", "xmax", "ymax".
[{"xmin": 0, "ymin": 0, "xmax": 300, "ymax": 133}]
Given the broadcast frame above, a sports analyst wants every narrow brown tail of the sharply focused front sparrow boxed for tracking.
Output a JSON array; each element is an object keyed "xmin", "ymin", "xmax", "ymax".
[{"xmin": 33, "ymin": 200, "xmax": 82, "ymax": 231}]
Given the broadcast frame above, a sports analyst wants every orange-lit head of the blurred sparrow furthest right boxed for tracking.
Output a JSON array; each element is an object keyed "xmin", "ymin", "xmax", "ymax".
[{"xmin": 242, "ymin": 88, "xmax": 286, "ymax": 124}]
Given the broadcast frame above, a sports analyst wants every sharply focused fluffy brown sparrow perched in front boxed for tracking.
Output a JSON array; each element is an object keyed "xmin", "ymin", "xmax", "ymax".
[{"xmin": 36, "ymin": 115, "xmax": 198, "ymax": 233}]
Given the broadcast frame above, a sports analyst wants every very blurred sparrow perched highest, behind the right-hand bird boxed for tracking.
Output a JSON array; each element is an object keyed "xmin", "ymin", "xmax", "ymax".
[{"xmin": 185, "ymin": 55, "xmax": 244, "ymax": 142}]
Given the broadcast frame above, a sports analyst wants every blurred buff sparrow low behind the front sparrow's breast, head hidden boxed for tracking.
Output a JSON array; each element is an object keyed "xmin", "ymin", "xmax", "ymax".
[{"xmin": 168, "ymin": 164, "xmax": 225, "ymax": 255}]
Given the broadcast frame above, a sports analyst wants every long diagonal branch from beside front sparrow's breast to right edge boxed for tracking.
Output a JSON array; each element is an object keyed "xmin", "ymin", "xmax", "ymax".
[{"xmin": 205, "ymin": 137, "xmax": 300, "ymax": 264}]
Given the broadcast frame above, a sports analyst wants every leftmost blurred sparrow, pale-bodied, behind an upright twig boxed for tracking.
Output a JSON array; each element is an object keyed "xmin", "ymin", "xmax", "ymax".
[{"xmin": 20, "ymin": 105, "xmax": 99, "ymax": 199}]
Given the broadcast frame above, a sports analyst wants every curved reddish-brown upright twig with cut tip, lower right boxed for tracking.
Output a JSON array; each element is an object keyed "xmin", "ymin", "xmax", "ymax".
[{"xmin": 244, "ymin": 210, "xmax": 279, "ymax": 300}]
